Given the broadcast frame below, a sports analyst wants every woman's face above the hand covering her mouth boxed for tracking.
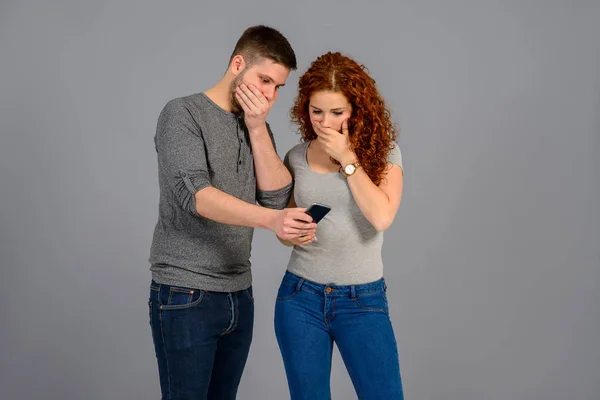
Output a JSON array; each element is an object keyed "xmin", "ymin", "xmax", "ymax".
[{"xmin": 308, "ymin": 91, "xmax": 352, "ymax": 132}]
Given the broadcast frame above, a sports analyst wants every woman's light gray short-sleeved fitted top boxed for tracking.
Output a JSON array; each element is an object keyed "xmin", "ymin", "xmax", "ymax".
[{"xmin": 284, "ymin": 142, "xmax": 402, "ymax": 285}]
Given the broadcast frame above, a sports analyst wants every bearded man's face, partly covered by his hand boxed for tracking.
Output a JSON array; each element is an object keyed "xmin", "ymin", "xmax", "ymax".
[{"xmin": 231, "ymin": 58, "xmax": 290, "ymax": 114}]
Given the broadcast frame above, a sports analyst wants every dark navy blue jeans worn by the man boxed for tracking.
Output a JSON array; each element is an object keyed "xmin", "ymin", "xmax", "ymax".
[{"xmin": 149, "ymin": 281, "xmax": 254, "ymax": 400}]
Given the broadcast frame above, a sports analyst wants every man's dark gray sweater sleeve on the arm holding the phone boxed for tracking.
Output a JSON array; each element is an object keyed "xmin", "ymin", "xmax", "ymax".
[{"xmin": 155, "ymin": 99, "xmax": 211, "ymax": 216}]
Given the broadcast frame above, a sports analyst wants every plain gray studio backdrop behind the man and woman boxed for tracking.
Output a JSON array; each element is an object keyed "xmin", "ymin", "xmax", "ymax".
[{"xmin": 0, "ymin": 0, "xmax": 600, "ymax": 400}]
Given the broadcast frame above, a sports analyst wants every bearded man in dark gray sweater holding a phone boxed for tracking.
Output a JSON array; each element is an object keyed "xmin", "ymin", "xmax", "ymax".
[{"xmin": 149, "ymin": 26, "xmax": 316, "ymax": 400}]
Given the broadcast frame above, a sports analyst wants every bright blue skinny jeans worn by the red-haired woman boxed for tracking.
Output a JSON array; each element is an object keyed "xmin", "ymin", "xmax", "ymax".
[{"xmin": 275, "ymin": 272, "xmax": 403, "ymax": 400}]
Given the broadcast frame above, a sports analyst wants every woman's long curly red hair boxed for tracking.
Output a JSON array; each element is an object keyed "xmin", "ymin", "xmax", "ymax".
[{"xmin": 290, "ymin": 52, "xmax": 397, "ymax": 185}]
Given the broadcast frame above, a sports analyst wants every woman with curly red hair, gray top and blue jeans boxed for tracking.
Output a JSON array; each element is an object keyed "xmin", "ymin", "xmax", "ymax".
[{"xmin": 275, "ymin": 53, "xmax": 403, "ymax": 400}]
